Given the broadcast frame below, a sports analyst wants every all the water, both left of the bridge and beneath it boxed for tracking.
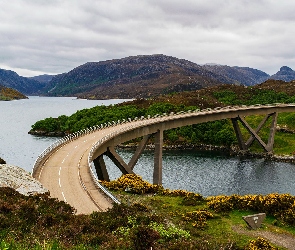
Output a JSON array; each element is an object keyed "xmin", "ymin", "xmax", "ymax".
[{"xmin": 0, "ymin": 97, "xmax": 295, "ymax": 196}]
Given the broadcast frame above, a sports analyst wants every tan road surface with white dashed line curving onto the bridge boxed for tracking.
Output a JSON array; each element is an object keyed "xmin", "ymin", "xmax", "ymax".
[{"xmin": 35, "ymin": 128, "xmax": 122, "ymax": 214}]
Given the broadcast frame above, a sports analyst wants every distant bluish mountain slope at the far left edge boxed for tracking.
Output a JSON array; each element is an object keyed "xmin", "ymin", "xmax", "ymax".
[{"xmin": 0, "ymin": 69, "xmax": 45, "ymax": 95}]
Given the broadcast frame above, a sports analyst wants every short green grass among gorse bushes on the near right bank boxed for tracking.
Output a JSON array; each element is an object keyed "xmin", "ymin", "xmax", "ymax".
[{"xmin": 115, "ymin": 191, "xmax": 295, "ymax": 249}]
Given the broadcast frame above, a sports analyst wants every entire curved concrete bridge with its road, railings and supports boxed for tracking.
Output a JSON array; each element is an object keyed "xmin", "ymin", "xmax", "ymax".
[{"xmin": 32, "ymin": 104, "xmax": 295, "ymax": 213}]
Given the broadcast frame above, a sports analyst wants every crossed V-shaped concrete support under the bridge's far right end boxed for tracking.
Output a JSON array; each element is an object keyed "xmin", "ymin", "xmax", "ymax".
[{"xmin": 231, "ymin": 112, "xmax": 278, "ymax": 153}]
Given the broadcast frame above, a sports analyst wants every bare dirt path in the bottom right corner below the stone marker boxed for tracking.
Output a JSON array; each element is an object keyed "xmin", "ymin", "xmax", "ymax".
[{"xmin": 232, "ymin": 226, "xmax": 295, "ymax": 250}]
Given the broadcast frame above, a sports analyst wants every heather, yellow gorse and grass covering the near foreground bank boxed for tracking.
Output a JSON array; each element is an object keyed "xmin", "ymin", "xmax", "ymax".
[{"xmin": 0, "ymin": 175, "xmax": 295, "ymax": 250}]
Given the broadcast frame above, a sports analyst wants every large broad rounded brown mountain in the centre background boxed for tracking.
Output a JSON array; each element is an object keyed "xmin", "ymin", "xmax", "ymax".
[{"xmin": 46, "ymin": 55, "xmax": 238, "ymax": 99}]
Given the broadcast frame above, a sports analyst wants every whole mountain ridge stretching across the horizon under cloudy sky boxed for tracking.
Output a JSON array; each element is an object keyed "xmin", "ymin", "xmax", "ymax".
[{"xmin": 0, "ymin": 54, "xmax": 295, "ymax": 99}]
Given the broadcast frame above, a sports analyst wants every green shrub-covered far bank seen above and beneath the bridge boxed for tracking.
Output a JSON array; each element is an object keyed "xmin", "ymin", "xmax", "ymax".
[{"xmin": 30, "ymin": 82, "xmax": 295, "ymax": 155}]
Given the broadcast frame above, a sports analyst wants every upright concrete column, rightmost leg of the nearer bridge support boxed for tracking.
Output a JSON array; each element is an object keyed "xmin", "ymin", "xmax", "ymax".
[{"xmin": 153, "ymin": 130, "xmax": 163, "ymax": 185}]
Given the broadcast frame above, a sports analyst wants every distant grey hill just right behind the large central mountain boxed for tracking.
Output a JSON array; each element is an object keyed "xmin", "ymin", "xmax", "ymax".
[{"xmin": 203, "ymin": 64, "xmax": 269, "ymax": 86}]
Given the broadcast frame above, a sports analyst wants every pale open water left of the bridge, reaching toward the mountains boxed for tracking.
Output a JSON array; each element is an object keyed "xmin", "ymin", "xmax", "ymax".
[{"xmin": 0, "ymin": 96, "xmax": 128, "ymax": 171}]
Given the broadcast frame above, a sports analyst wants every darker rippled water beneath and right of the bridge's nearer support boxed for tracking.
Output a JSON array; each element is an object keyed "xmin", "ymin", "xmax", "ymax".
[{"xmin": 105, "ymin": 150, "xmax": 295, "ymax": 196}]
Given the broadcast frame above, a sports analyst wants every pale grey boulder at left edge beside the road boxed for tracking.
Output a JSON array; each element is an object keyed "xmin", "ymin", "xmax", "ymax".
[{"xmin": 0, "ymin": 164, "xmax": 48, "ymax": 195}]
